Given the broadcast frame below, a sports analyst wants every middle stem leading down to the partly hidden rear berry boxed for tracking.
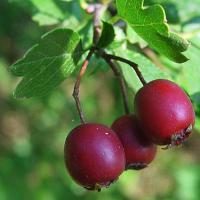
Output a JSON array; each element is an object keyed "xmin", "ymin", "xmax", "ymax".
[{"xmin": 101, "ymin": 57, "xmax": 130, "ymax": 114}]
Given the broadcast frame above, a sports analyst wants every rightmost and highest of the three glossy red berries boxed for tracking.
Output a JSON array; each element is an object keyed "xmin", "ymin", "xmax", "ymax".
[{"xmin": 134, "ymin": 79, "xmax": 195, "ymax": 147}]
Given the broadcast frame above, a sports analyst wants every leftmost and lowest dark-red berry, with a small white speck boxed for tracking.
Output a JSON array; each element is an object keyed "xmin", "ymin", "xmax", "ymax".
[{"xmin": 64, "ymin": 123, "xmax": 125, "ymax": 190}]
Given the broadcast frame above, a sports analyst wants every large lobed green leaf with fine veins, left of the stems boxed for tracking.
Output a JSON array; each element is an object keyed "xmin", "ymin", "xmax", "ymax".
[{"xmin": 11, "ymin": 29, "xmax": 83, "ymax": 98}]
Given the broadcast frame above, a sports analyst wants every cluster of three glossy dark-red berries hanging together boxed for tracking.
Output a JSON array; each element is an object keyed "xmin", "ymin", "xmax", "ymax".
[{"xmin": 64, "ymin": 80, "xmax": 195, "ymax": 190}]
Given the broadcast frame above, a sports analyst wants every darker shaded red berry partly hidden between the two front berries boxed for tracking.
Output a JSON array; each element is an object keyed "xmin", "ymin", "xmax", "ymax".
[{"xmin": 112, "ymin": 115, "xmax": 157, "ymax": 169}]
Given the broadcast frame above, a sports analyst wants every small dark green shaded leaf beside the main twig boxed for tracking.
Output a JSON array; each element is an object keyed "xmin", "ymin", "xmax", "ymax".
[{"xmin": 97, "ymin": 22, "xmax": 115, "ymax": 48}]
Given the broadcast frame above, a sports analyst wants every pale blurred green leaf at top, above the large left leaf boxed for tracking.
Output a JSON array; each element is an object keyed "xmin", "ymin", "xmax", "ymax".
[{"xmin": 29, "ymin": 0, "xmax": 86, "ymax": 28}]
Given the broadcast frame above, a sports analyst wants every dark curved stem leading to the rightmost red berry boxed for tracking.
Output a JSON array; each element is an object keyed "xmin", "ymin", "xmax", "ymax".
[{"xmin": 100, "ymin": 51, "xmax": 147, "ymax": 85}]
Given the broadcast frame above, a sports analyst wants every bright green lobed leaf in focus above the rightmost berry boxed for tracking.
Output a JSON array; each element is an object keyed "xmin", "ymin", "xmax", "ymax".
[{"xmin": 117, "ymin": 0, "xmax": 189, "ymax": 63}]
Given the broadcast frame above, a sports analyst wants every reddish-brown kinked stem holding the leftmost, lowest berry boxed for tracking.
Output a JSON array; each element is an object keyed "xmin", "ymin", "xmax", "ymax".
[{"xmin": 72, "ymin": 48, "xmax": 94, "ymax": 124}]
